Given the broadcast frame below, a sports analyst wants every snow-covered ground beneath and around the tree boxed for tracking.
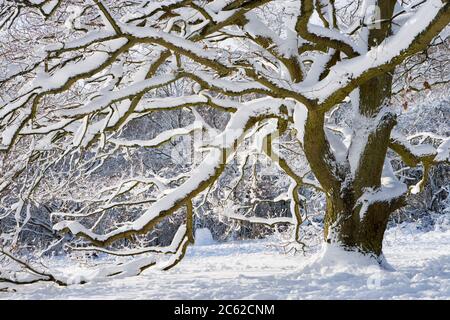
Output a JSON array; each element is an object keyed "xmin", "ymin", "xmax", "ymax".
[{"xmin": 0, "ymin": 224, "xmax": 450, "ymax": 299}]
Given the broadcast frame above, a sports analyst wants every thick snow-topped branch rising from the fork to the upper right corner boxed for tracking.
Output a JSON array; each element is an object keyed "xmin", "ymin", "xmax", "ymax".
[{"xmin": 297, "ymin": 0, "xmax": 450, "ymax": 108}]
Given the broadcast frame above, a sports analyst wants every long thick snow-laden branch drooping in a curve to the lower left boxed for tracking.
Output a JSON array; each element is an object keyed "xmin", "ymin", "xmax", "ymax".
[{"xmin": 54, "ymin": 103, "xmax": 282, "ymax": 246}]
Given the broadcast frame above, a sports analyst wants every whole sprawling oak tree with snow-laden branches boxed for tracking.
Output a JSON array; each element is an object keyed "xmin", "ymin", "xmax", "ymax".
[{"xmin": 0, "ymin": 0, "xmax": 450, "ymax": 283}]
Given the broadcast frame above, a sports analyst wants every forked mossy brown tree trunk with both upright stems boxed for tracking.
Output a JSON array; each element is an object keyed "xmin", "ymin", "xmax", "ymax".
[{"xmin": 304, "ymin": 0, "xmax": 403, "ymax": 257}]
